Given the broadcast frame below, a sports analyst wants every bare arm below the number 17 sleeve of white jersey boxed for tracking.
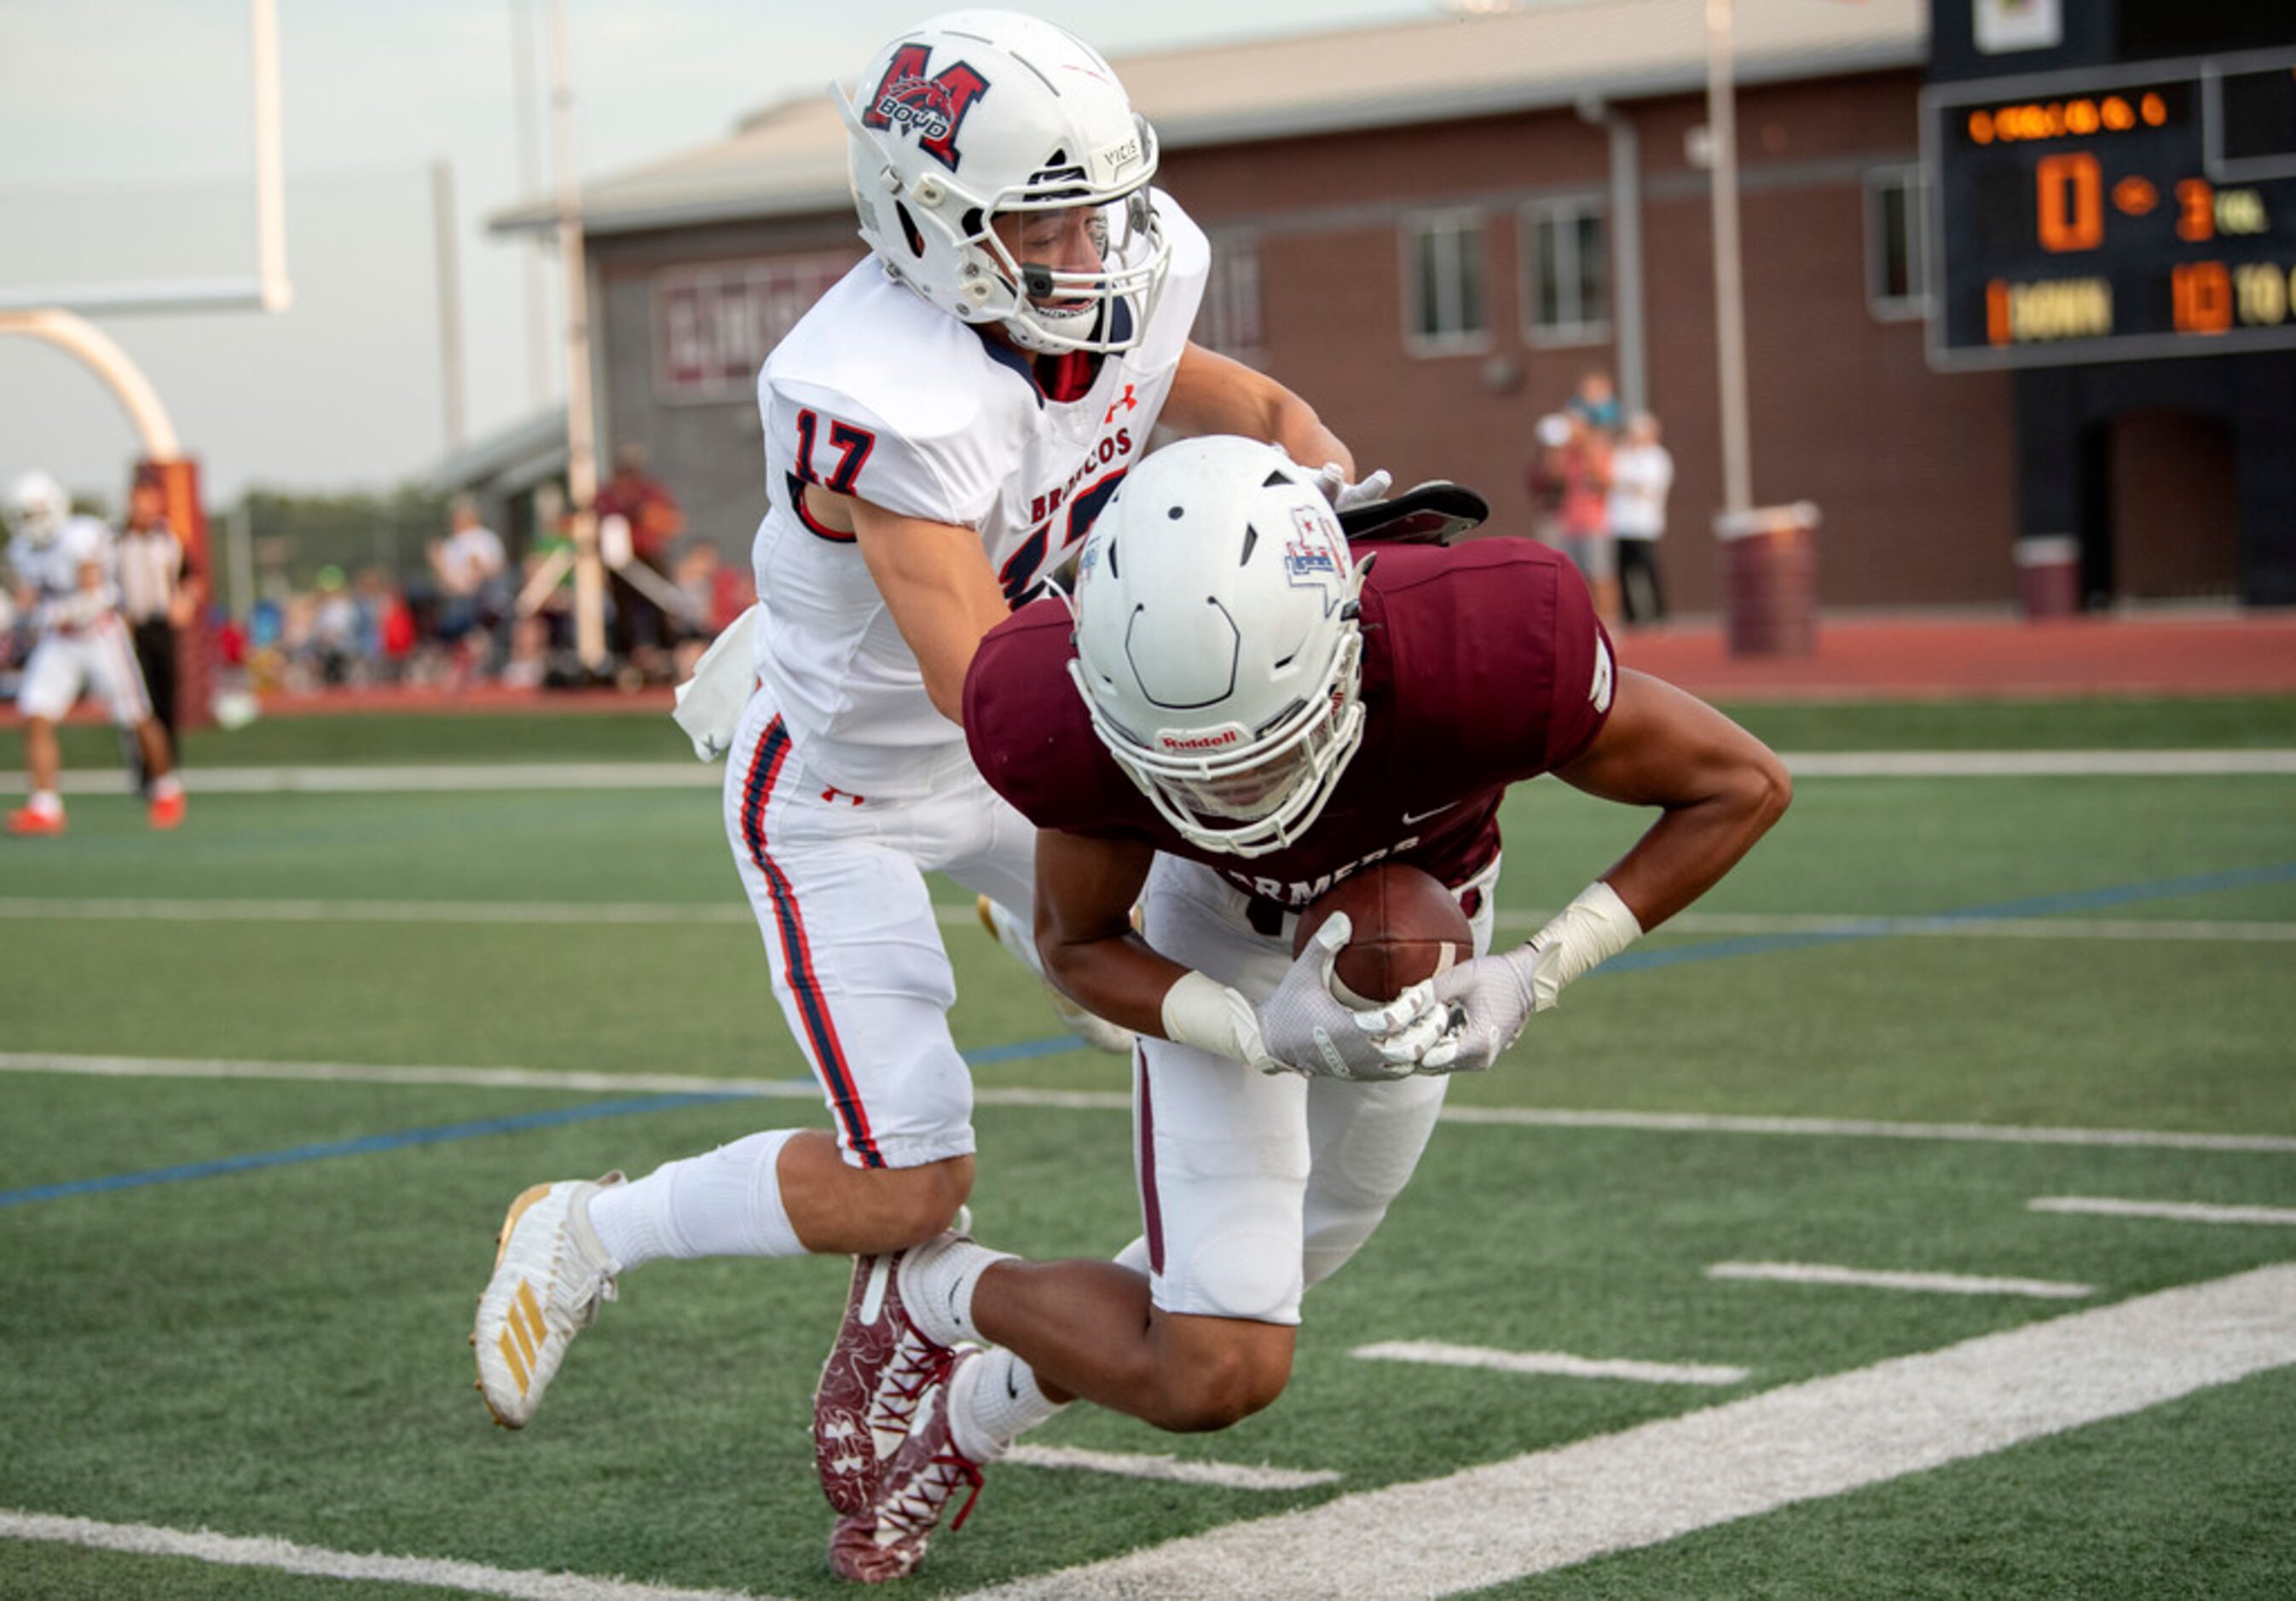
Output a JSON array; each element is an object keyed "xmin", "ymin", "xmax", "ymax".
[{"xmin": 845, "ymin": 487, "xmax": 1006, "ymax": 725}]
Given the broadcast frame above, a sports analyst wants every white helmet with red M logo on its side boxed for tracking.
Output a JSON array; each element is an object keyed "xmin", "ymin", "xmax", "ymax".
[{"xmin": 838, "ymin": 11, "xmax": 1171, "ymax": 351}]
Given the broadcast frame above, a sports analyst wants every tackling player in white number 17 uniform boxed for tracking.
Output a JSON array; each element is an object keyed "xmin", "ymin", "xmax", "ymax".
[{"xmin": 475, "ymin": 11, "xmax": 1378, "ymax": 1581}]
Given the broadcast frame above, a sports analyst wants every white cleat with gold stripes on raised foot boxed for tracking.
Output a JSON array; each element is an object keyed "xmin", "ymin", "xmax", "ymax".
[{"xmin": 471, "ymin": 1174, "xmax": 622, "ymax": 1429}]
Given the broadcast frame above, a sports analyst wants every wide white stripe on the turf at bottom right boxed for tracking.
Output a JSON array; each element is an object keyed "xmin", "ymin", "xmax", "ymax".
[{"xmin": 976, "ymin": 1266, "xmax": 2296, "ymax": 1601}]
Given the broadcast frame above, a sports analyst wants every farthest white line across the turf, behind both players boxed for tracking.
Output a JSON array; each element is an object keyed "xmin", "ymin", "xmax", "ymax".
[{"xmin": 31, "ymin": 748, "xmax": 2296, "ymax": 795}]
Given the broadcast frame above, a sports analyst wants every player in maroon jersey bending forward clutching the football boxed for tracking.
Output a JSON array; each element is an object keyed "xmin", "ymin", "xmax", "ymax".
[{"xmin": 817, "ymin": 439, "xmax": 1791, "ymax": 1570}]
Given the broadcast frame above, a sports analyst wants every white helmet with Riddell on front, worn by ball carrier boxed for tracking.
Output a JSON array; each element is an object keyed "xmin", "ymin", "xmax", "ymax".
[{"xmin": 1067, "ymin": 439, "xmax": 1371, "ymax": 857}]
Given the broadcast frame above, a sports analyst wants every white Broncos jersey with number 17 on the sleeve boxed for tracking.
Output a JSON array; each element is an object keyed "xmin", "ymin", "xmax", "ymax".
[{"xmin": 753, "ymin": 193, "xmax": 1210, "ymax": 797}]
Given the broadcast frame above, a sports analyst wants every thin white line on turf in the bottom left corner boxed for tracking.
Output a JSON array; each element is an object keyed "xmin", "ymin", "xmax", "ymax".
[{"xmin": 0, "ymin": 1509, "xmax": 772, "ymax": 1601}]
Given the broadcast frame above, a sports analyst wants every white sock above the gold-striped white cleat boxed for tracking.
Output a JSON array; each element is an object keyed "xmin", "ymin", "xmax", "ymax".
[{"xmin": 590, "ymin": 1128, "xmax": 806, "ymax": 1270}]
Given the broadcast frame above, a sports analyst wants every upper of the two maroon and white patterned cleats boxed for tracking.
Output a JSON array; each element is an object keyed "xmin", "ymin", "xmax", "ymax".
[{"xmin": 813, "ymin": 1251, "xmax": 948, "ymax": 1516}]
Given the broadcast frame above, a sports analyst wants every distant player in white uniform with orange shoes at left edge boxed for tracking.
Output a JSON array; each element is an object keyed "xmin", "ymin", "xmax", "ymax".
[{"xmin": 7, "ymin": 473, "xmax": 183, "ymax": 834}]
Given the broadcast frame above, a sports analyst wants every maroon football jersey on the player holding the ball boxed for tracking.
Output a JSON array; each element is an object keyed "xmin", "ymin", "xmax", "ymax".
[{"xmin": 964, "ymin": 540, "xmax": 1616, "ymax": 907}]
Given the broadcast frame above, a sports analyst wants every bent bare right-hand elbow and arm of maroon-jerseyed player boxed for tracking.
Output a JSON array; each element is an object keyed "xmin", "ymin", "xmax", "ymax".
[{"xmin": 1557, "ymin": 671, "xmax": 1793, "ymax": 933}]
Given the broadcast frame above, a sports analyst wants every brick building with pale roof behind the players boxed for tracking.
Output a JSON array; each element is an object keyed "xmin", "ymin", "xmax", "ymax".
[{"xmin": 498, "ymin": 0, "xmax": 2296, "ymax": 611}]
